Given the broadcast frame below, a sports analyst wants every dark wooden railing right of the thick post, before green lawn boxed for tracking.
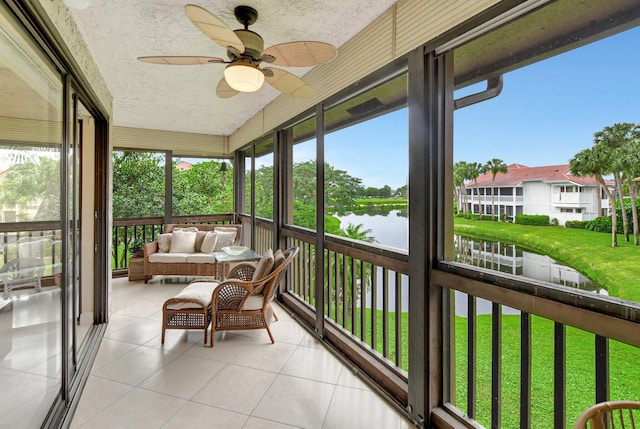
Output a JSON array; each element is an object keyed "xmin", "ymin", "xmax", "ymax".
[{"xmin": 432, "ymin": 262, "xmax": 640, "ymax": 428}]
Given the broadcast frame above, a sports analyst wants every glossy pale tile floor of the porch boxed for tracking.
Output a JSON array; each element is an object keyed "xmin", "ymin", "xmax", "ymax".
[{"xmin": 71, "ymin": 278, "xmax": 411, "ymax": 429}]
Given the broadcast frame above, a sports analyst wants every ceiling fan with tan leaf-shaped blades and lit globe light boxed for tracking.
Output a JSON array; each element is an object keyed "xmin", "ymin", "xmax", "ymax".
[{"xmin": 138, "ymin": 4, "xmax": 338, "ymax": 98}]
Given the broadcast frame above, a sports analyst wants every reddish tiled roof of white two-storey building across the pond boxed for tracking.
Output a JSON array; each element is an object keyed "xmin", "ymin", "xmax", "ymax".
[{"xmin": 466, "ymin": 164, "xmax": 598, "ymax": 187}]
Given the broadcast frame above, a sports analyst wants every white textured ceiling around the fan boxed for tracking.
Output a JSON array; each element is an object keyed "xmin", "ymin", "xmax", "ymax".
[{"xmin": 67, "ymin": 0, "xmax": 397, "ymax": 135}]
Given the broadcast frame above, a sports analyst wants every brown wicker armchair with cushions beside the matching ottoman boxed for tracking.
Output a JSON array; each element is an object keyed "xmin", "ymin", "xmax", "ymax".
[{"xmin": 211, "ymin": 247, "xmax": 299, "ymax": 347}]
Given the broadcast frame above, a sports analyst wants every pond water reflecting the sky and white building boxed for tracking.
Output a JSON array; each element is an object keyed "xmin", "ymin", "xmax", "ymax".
[{"xmin": 338, "ymin": 210, "xmax": 607, "ymax": 316}]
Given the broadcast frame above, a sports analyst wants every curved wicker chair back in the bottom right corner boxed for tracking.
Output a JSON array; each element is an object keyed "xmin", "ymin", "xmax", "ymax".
[{"xmin": 573, "ymin": 401, "xmax": 640, "ymax": 429}]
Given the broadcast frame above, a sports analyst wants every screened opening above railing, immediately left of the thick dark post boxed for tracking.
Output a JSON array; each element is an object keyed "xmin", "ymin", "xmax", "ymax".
[{"xmin": 325, "ymin": 74, "xmax": 409, "ymax": 250}]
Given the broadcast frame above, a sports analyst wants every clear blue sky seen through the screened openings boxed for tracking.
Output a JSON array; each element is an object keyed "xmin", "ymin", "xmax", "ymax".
[{"xmin": 262, "ymin": 28, "xmax": 640, "ymax": 189}]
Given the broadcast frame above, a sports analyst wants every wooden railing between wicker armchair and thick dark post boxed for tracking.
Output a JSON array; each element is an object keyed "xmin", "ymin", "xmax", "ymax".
[{"xmin": 281, "ymin": 222, "xmax": 409, "ymax": 403}]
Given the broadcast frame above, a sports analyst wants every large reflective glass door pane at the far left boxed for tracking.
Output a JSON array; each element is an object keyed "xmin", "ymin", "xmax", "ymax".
[{"xmin": 0, "ymin": 6, "xmax": 64, "ymax": 429}]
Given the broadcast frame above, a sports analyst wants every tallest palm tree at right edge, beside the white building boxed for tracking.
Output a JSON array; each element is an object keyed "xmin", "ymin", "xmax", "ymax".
[{"xmin": 593, "ymin": 122, "xmax": 640, "ymax": 241}]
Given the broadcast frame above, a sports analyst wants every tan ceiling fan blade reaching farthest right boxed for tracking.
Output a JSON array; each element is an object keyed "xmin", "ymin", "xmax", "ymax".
[{"xmin": 262, "ymin": 42, "xmax": 338, "ymax": 67}]
